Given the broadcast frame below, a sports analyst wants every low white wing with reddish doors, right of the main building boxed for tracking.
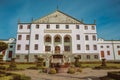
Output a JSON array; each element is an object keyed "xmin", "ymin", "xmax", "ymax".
[{"xmin": 98, "ymin": 39, "xmax": 120, "ymax": 60}]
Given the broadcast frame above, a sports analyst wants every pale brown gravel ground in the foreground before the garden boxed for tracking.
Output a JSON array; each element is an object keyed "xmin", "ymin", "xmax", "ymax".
[{"xmin": 9, "ymin": 68, "xmax": 120, "ymax": 80}]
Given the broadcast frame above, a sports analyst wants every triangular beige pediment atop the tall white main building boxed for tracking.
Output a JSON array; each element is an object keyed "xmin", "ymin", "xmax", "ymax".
[{"xmin": 32, "ymin": 10, "xmax": 81, "ymax": 23}]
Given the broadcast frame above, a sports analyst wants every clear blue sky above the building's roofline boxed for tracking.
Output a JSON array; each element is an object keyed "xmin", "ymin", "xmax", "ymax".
[{"xmin": 0, "ymin": 0, "xmax": 120, "ymax": 40}]
